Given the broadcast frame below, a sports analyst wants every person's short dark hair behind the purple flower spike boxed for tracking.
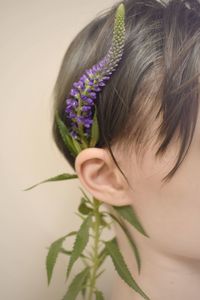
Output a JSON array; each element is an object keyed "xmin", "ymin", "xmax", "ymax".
[{"xmin": 52, "ymin": 0, "xmax": 200, "ymax": 186}]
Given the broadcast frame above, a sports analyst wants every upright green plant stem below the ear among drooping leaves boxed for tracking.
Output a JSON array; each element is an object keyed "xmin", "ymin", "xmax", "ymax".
[{"xmin": 88, "ymin": 198, "xmax": 101, "ymax": 300}]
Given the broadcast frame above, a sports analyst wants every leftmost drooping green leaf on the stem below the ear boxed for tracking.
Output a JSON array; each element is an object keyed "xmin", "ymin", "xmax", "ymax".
[{"xmin": 46, "ymin": 231, "xmax": 77, "ymax": 285}]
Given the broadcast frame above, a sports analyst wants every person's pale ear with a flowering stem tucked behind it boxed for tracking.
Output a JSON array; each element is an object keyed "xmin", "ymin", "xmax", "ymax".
[{"xmin": 75, "ymin": 148, "xmax": 131, "ymax": 206}]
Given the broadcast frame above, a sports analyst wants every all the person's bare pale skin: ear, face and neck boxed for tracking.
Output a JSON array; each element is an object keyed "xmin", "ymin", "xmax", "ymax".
[{"xmin": 75, "ymin": 113, "xmax": 200, "ymax": 300}]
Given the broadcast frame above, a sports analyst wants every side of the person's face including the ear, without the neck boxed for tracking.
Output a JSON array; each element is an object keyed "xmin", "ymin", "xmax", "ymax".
[{"xmin": 75, "ymin": 109, "xmax": 200, "ymax": 260}]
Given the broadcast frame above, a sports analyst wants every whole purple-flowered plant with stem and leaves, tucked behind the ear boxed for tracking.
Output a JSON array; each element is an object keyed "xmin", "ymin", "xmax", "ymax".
[{"xmin": 25, "ymin": 3, "xmax": 150, "ymax": 300}]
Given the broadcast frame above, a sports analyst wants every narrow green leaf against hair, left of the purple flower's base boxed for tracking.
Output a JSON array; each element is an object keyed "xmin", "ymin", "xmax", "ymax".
[{"xmin": 55, "ymin": 111, "xmax": 78, "ymax": 157}]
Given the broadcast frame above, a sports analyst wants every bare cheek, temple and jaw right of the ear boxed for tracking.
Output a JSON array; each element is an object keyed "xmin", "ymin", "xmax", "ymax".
[{"xmin": 127, "ymin": 137, "xmax": 200, "ymax": 259}]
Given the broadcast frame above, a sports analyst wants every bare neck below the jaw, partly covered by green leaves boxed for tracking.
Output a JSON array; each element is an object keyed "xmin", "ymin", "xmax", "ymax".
[{"xmin": 111, "ymin": 220, "xmax": 200, "ymax": 300}]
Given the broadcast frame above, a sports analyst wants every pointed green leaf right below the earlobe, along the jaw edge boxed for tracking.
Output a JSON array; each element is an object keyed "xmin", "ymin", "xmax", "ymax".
[{"xmin": 112, "ymin": 205, "xmax": 149, "ymax": 237}]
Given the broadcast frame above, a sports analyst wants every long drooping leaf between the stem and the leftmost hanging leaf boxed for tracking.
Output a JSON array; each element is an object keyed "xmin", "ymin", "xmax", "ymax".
[{"xmin": 67, "ymin": 214, "xmax": 92, "ymax": 277}]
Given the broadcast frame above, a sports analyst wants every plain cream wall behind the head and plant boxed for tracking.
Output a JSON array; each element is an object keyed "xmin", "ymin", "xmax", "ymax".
[{"xmin": 0, "ymin": 0, "xmax": 119, "ymax": 300}]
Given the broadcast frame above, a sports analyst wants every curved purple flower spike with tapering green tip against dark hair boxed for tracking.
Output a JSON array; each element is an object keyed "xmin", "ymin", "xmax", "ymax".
[{"xmin": 65, "ymin": 3, "xmax": 125, "ymax": 145}]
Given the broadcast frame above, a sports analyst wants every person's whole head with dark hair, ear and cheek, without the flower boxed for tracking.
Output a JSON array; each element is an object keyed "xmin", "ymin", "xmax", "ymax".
[{"xmin": 53, "ymin": 0, "xmax": 200, "ymax": 258}]
